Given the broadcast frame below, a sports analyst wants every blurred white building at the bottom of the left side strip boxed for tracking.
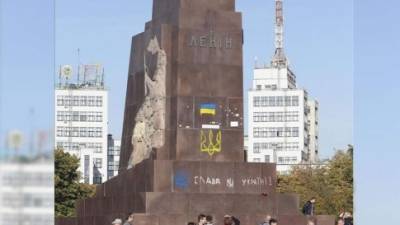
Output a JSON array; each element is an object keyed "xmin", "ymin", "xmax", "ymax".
[{"xmin": 0, "ymin": 159, "xmax": 54, "ymax": 225}]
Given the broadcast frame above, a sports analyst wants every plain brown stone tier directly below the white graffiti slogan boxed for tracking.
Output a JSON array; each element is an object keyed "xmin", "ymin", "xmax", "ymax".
[{"xmin": 77, "ymin": 192, "xmax": 299, "ymax": 217}]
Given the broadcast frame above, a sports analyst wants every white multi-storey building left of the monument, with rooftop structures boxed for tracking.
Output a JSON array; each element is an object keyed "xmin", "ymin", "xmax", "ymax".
[{"xmin": 55, "ymin": 65, "xmax": 108, "ymax": 184}]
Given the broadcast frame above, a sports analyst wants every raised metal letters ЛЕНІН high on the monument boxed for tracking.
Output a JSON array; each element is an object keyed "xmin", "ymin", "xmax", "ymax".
[{"xmin": 189, "ymin": 30, "xmax": 233, "ymax": 49}]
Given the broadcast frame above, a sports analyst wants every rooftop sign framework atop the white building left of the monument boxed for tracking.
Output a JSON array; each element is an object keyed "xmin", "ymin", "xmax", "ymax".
[{"xmin": 56, "ymin": 64, "xmax": 105, "ymax": 89}]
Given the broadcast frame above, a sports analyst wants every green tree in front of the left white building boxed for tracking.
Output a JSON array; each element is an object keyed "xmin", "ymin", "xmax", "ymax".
[{"xmin": 54, "ymin": 149, "xmax": 95, "ymax": 217}]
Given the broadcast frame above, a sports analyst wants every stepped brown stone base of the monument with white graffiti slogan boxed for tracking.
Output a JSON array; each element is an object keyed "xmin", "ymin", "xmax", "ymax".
[{"xmin": 57, "ymin": 159, "xmax": 334, "ymax": 225}]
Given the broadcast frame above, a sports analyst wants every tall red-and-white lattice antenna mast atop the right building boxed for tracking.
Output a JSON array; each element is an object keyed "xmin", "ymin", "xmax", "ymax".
[{"xmin": 272, "ymin": 0, "xmax": 287, "ymax": 66}]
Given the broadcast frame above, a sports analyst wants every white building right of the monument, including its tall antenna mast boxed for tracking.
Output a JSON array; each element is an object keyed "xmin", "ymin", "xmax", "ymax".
[{"xmin": 247, "ymin": 0, "xmax": 318, "ymax": 173}]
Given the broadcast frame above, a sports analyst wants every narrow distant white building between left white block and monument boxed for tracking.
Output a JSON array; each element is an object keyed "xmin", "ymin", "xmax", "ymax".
[{"xmin": 107, "ymin": 134, "xmax": 121, "ymax": 179}]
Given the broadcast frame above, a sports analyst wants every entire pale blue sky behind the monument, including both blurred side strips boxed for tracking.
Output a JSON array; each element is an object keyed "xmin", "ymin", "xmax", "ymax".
[{"xmin": 0, "ymin": 0, "xmax": 400, "ymax": 225}]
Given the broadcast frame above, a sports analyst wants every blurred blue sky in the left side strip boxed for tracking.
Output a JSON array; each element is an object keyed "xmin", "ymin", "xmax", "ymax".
[{"xmin": 0, "ymin": 0, "xmax": 54, "ymax": 154}]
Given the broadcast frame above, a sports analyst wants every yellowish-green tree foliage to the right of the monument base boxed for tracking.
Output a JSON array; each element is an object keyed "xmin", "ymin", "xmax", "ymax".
[{"xmin": 277, "ymin": 146, "xmax": 353, "ymax": 215}]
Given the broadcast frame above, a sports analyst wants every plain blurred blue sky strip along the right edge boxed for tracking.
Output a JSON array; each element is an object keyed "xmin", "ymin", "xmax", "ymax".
[{"xmin": 354, "ymin": 0, "xmax": 400, "ymax": 225}]
